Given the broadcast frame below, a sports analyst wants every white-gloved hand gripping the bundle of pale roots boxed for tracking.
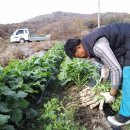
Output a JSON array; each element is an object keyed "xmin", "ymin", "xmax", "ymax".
[{"xmin": 100, "ymin": 92, "xmax": 115, "ymax": 103}]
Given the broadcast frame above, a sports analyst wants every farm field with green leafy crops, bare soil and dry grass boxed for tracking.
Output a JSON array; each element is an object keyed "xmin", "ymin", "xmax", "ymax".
[{"xmin": 0, "ymin": 41, "xmax": 130, "ymax": 130}]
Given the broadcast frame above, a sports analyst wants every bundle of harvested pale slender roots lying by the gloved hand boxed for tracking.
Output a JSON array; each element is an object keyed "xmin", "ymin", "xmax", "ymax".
[{"xmin": 80, "ymin": 87, "xmax": 105, "ymax": 110}]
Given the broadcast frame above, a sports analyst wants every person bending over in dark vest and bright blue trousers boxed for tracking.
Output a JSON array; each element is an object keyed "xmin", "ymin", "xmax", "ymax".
[{"xmin": 64, "ymin": 23, "xmax": 130, "ymax": 126}]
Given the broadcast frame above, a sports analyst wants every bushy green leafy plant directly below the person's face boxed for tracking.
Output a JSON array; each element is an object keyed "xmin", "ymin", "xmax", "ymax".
[{"xmin": 58, "ymin": 57, "xmax": 99, "ymax": 88}]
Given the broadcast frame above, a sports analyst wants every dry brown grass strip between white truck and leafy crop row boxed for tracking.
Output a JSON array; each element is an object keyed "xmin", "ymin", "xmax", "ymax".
[{"xmin": 0, "ymin": 41, "xmax": 55, "ymax": 67}]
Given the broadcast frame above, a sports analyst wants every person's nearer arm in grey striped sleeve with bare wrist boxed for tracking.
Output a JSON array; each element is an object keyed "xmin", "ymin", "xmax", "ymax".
[{"xmin": 93, "ymin": 37, "xmax": 122, "ymax": 96}]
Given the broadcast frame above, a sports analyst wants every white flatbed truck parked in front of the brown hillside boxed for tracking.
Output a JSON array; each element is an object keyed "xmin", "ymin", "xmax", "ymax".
[{"xmin": 10, "ymin": 28, "xmax": 51, "ymax": 43}]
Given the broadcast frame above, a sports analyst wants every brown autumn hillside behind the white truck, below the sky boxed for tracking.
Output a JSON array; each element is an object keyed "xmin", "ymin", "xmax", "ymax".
[{"xmin": 0, "ymin": 11, "xmax": 130, "ymax": 40}]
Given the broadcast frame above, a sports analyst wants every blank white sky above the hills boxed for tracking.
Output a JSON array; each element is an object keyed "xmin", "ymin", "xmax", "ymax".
[{"xmin": 0, "ymin": 0, "xmax": 130, "ymax": 24}]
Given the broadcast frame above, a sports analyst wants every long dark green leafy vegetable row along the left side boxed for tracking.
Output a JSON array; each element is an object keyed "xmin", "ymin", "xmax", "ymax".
[{"xmin": 0, "ymin": 44, "xmax": 64, "ymax": 130}]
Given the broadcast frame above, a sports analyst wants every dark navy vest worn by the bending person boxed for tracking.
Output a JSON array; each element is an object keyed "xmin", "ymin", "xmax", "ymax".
[{"xmin": 81, "ymin": 23, "xmax": 130, "ymax": 67}]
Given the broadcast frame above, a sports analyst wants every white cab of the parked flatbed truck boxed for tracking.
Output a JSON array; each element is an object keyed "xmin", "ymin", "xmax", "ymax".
[{"xmin": 10, "ymin": 28, "xmax": 30, "ymax": 43}]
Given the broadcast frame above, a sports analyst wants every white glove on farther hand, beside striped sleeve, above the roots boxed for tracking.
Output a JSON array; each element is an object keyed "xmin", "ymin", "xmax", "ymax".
[{"xmin": 99, "ymin": 65, "xmax": 109, "ymax": 82}]
